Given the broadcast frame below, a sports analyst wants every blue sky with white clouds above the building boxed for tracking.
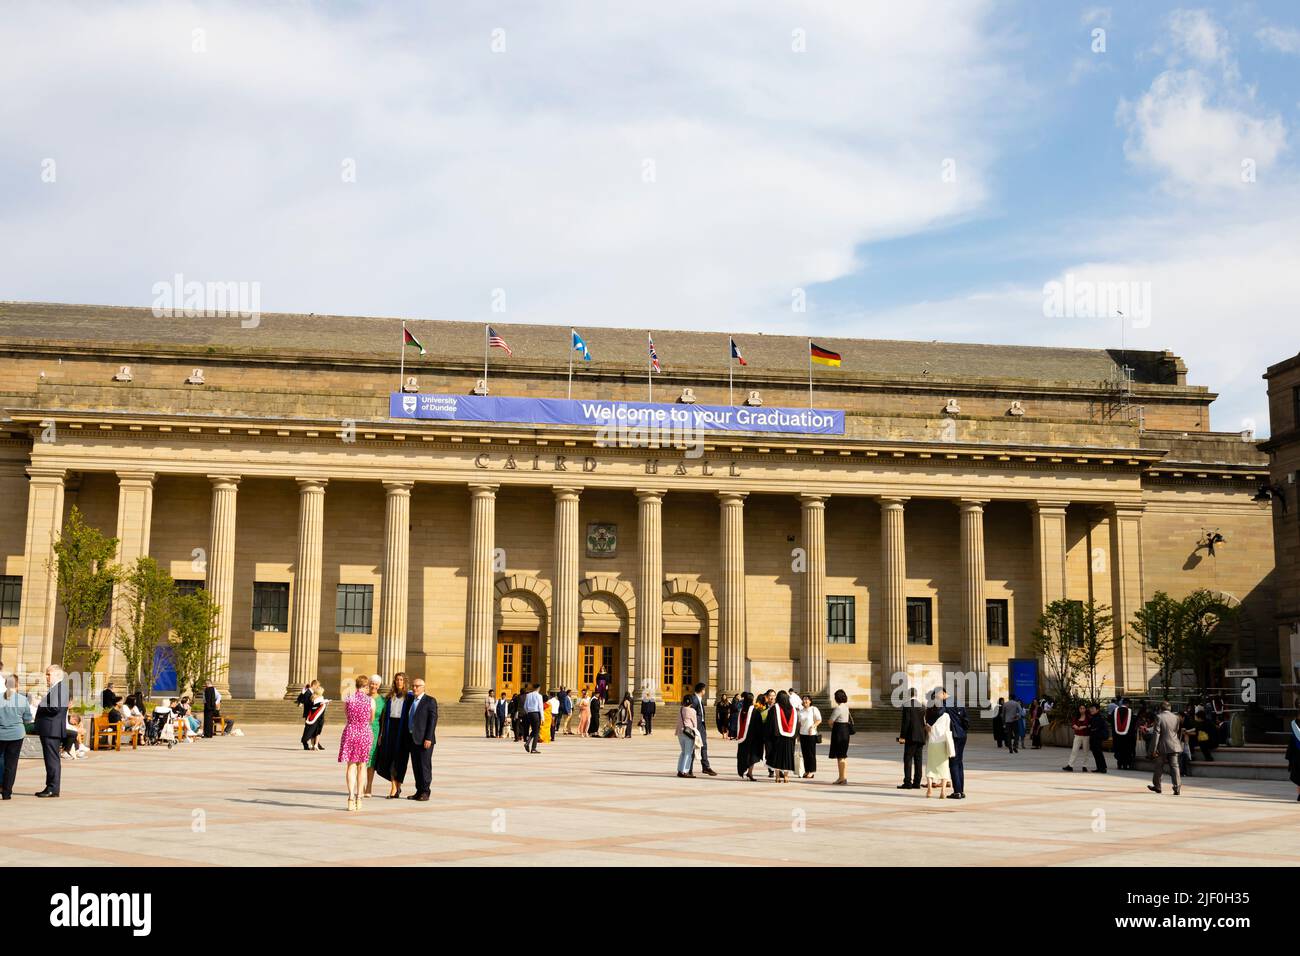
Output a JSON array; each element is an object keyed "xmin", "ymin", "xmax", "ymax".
[{"xmin": 0, "ymin": 0, "xmax": 1300, "ymax": 436}]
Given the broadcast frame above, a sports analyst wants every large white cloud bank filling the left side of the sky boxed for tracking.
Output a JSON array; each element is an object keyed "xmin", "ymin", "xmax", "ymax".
[{"xmin": 0, "ymin": 0, "xmax": 1017, "ymax": 328}]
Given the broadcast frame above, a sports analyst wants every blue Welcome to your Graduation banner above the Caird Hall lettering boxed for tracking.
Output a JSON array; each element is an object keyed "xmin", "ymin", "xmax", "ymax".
[{"xmin": 389, "ymin": 392, "xmax": 844, "ymax": 434}]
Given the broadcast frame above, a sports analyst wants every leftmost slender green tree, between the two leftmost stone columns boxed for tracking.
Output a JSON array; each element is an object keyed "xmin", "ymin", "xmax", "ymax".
[{"xmin": 51, "ymin": 505, "xmax": 118, "ymax": 671}]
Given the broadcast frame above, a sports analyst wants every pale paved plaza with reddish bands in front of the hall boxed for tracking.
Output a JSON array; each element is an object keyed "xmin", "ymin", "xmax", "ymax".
[{"xmin": 0, "ymin": 726, "xmax": 1300, "ymax": 866}]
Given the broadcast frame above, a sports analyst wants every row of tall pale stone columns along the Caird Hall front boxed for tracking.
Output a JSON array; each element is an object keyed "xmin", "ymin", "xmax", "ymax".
[{"xmin": 12, "ymin": 467, "xmax": 1144, "ymax": 700}]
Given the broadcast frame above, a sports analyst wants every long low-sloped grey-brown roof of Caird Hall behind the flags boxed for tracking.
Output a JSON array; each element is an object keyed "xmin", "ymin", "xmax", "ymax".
[{"xmin": 0, "ymin": 302, "xmax": 1182, "ymax": 385}]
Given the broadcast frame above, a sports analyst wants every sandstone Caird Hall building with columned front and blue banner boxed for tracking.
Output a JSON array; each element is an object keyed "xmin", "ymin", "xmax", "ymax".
[{"xmin": 0, "ymin": 303, "xmax": 1291, "ymax": 706}]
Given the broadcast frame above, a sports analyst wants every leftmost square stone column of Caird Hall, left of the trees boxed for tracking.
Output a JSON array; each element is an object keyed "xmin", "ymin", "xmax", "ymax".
[{"xmin": 18, "ymin": 466, "xmax": 64, "ymax": 674}]
